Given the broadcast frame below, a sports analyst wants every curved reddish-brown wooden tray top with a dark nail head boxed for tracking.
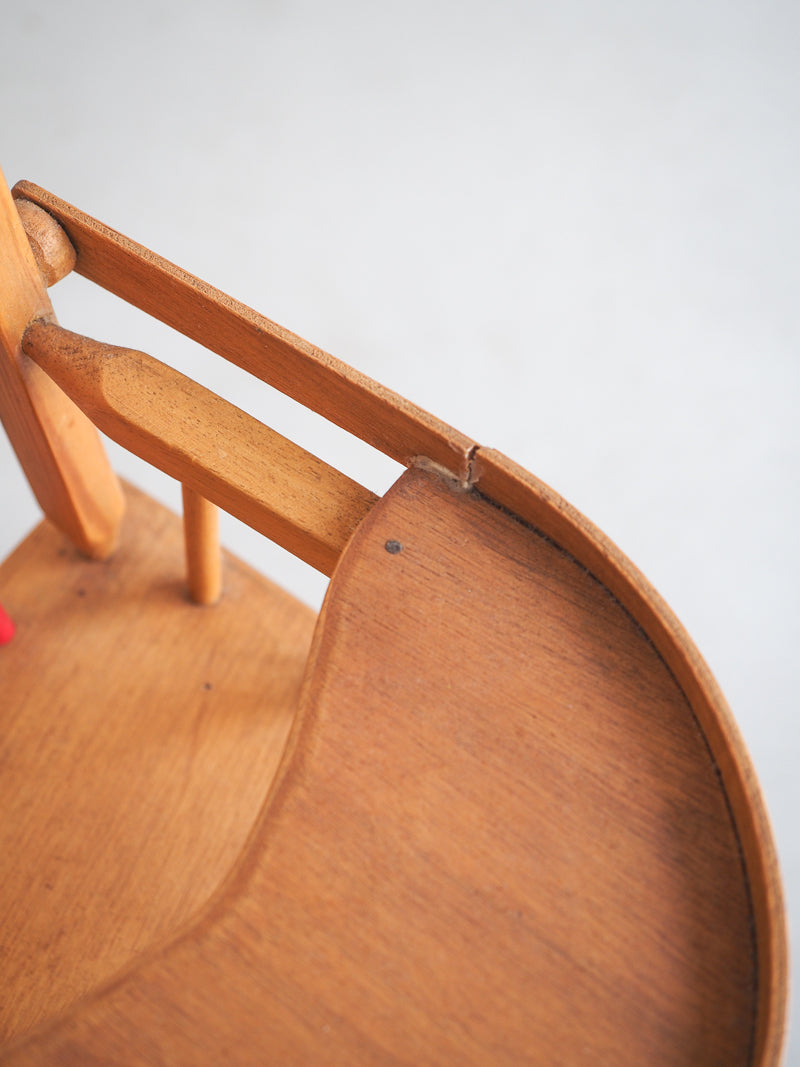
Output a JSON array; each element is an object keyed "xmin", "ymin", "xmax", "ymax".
[{"xmin": 1, "ymin": 469, "xmax": 780, "ymax": 1067}]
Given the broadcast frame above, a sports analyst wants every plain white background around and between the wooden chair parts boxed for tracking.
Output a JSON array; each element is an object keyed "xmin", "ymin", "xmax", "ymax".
[{"xmin": 0, "ymin": 0, "xmax": 800, "ymax": 1064}]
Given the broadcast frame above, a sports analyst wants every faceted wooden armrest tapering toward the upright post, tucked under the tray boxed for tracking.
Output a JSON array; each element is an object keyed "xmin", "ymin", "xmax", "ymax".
[{"xmin": 22, "ymin": 321, "xmax": 378, "ymax": 575}]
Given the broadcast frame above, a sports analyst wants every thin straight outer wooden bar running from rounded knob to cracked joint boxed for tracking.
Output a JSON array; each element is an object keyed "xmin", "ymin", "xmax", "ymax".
[{"xmin": 13, "ymin": 181, "xmax": 475, "ymax": 480}]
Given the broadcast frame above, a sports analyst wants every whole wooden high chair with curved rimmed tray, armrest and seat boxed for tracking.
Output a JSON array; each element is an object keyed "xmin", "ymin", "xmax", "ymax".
[{"xmin": 0, "ymin": 166, "xmax": 786, "ymax": 1067}]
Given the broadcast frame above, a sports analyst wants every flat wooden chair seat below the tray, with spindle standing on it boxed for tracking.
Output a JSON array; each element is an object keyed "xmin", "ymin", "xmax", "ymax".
[{"xmin": 0, "ymin": 490, "xmax": 315, "ymax": 1049}]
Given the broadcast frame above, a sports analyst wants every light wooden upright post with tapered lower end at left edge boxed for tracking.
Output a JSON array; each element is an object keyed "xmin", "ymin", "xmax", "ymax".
[{"xmin": 0, "ymin": 166, "xmax": 123, "ymax": 558}]
